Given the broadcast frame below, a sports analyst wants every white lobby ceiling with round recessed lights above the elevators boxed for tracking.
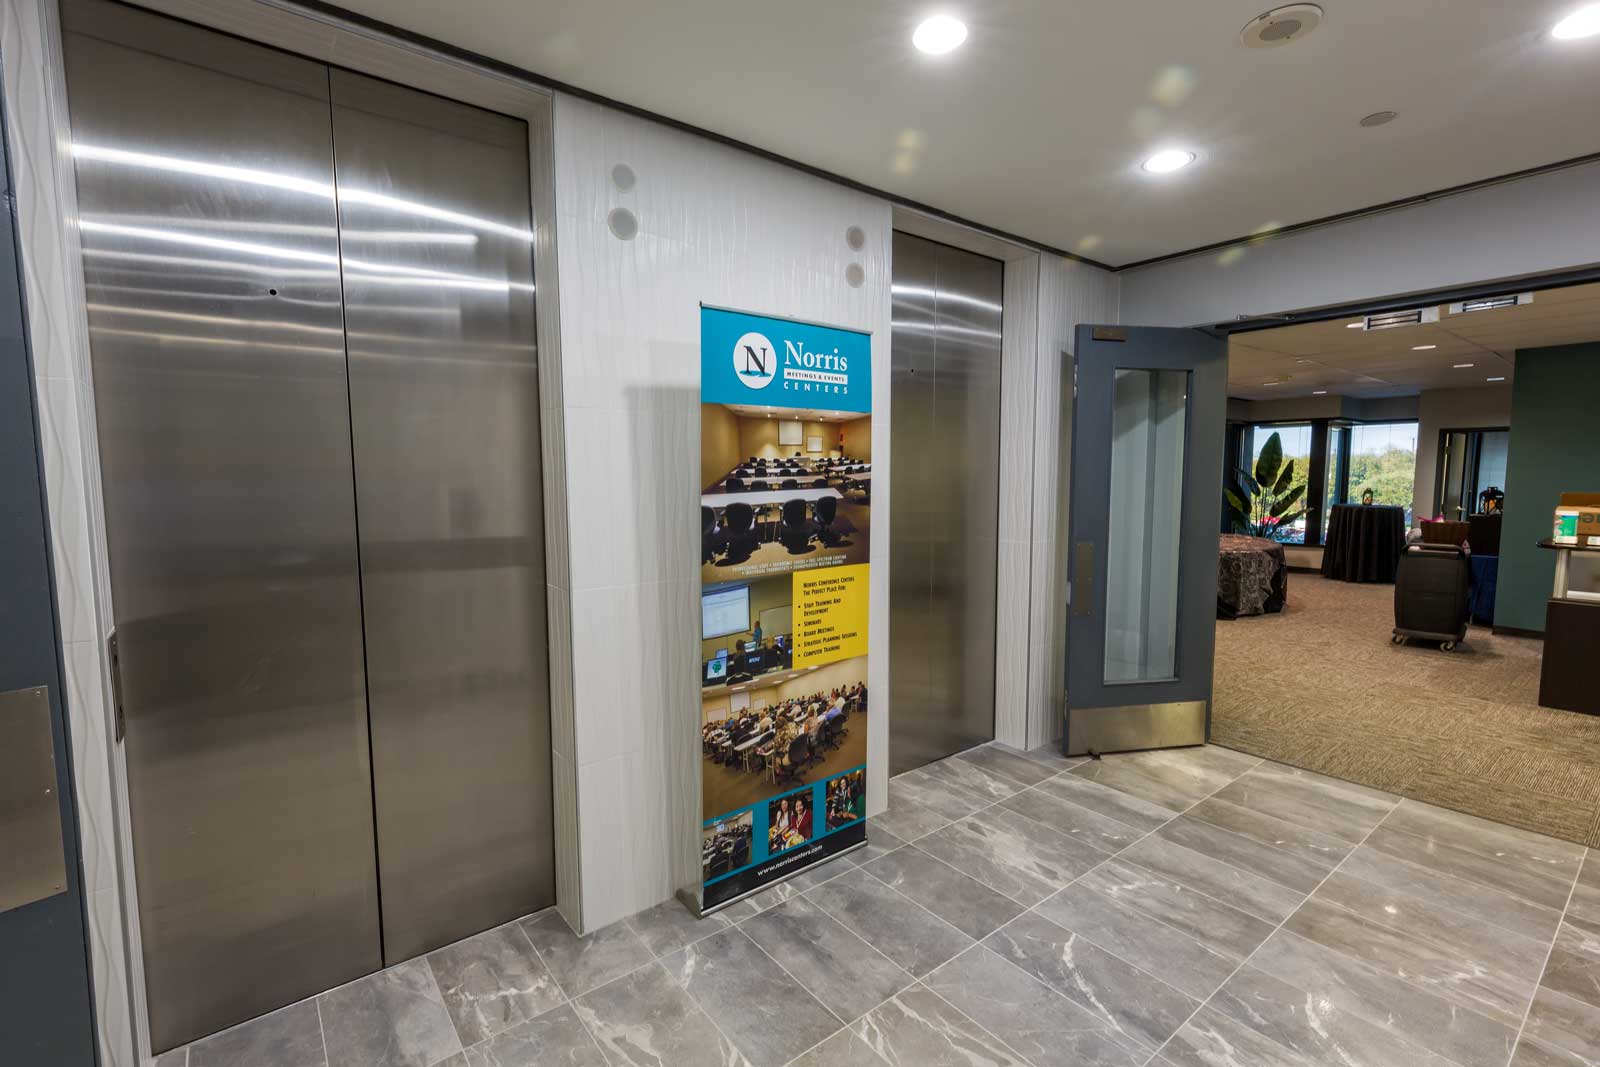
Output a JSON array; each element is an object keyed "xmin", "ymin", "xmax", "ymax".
[{"xmin": 328, "ymin": 0, "xmax": 1600, "ymax": 264}]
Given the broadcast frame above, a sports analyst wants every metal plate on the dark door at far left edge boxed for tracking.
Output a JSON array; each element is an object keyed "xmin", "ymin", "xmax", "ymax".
[{"xmin": 0, "ymin": 686, "xmax": 67, "ymax": 912}]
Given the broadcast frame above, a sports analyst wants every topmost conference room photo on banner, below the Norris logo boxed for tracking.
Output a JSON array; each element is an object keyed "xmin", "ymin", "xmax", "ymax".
[{"xmin": 701, "ymin": 403, "xmax": 872, "ymax": 584}]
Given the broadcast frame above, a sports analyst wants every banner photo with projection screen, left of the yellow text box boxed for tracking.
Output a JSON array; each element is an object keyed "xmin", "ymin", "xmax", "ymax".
[{"xmin": 701, "ymin": 574, "xmax": 795, "ymax": 691}]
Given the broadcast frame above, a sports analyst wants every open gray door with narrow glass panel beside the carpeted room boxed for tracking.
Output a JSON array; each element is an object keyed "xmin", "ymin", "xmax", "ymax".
[{"xmin": 1066, "ymin": 326, "xmax": 1227, "ymax": 755}]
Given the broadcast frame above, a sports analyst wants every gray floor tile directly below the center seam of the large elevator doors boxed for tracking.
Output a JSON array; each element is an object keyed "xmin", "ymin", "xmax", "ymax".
[{"xmin": 317, "ymin": 960, "xmax": 461, "ymax": 1067}]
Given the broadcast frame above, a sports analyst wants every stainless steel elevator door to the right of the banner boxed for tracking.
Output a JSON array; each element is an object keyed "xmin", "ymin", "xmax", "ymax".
[{"xmin": 890, "ymin": 234, "xmax": 1005, "ymax": 774}]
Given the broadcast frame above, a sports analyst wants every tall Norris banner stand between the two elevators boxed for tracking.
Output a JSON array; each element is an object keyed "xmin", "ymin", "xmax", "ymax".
[{"xmin": 699, "ymin": 307, "xmax": 872, "ymax": 913}]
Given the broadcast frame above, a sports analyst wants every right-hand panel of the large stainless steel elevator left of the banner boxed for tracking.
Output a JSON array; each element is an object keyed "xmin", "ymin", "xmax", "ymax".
[{"xmin": 331, "ymin": 70, "xmax": 555, "ymax": 963}]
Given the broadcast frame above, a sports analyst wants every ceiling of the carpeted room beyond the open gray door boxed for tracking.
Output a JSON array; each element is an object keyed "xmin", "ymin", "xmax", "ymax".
[{"xmin": 1227, "ymin": 283, "xmax": 1600, "ymax": 400}]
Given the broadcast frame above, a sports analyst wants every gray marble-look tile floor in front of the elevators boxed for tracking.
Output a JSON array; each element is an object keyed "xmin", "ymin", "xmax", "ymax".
[{"xmin": 157, "ymin": 745, "xmax": 1600, "ymax": 1067}]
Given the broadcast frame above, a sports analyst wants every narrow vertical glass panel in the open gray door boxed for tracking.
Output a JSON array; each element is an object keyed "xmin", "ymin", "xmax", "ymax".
[{"xmin": 1104, "ymin": 370, "xmax": 1189, "ymax": 683}]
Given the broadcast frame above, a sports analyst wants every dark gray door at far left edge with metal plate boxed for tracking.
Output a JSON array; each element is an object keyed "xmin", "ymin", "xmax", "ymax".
[{"xmin": 0, "ymin": 99, "xmax": 94, "ymax": 1067}]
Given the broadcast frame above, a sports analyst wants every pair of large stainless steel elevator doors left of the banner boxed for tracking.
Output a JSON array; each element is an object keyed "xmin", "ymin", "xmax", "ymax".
[{"xmin": 67, "ymin": 0, "xmax": 554, "ymax": 1051}]
